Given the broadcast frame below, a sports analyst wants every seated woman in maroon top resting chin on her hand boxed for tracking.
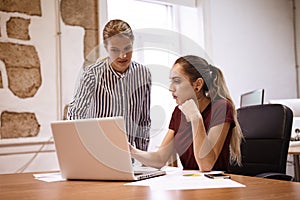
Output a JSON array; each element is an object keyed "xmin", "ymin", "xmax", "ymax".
[{"xmin": 130, "ymin": 55, "xmax": 242, "ymax": 171}]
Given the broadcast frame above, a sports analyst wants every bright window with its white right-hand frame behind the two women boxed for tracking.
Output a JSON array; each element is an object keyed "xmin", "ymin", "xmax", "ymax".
[{"xmin": 106, "ymin": 0, "xmax": 204, "ymax": 154}]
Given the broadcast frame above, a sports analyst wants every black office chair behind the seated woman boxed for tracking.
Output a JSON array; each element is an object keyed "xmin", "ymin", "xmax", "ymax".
[{"xmin": 229, "ymin": 104, "xmax": 293, "ymax": 181}]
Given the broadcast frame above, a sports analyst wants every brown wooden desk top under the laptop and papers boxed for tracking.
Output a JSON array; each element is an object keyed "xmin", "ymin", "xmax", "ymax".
[{"xmin": 0, "ymin": 173, "xmax": 300, "ymax": 200}]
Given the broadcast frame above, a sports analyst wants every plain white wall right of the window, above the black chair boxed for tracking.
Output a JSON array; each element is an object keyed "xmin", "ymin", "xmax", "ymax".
[{"xmin": 198, "ymin": 0, "xmax": 300, "ymax": 106}]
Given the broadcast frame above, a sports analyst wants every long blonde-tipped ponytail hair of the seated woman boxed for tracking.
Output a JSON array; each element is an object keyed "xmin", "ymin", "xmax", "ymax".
[{"xmin": 175, "ymin": 55, "xmax": 243, "ymax": 165}]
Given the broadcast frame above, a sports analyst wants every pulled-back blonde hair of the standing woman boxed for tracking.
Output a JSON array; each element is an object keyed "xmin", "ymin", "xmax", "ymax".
[{"xmin": 103, "ymin": 19, "xmax": 134, "ymax": 45}]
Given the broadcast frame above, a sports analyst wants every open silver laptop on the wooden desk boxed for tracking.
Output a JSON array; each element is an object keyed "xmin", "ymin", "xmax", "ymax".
[{"xmin": 51, "ymin": 117, "xmax": 166, "ymax": 181}]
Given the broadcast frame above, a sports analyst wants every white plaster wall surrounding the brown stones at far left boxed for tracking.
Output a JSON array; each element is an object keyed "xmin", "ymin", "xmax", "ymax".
[{"xmin": 0, "ymin": 0, "xmax": 60, "ymax": 173}]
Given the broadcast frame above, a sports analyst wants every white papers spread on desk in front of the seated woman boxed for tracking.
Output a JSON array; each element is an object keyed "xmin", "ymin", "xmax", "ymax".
[{"xmin": 125, "ymin": 170, "xmax": 245, "ymax": 190}]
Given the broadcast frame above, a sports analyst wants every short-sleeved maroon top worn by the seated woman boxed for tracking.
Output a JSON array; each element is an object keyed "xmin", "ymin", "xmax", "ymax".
[{"xmin": 169, "ymin": 99, "xmax": 235, "ymax": 171}]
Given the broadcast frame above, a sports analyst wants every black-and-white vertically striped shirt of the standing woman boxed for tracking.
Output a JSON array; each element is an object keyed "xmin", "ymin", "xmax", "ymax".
[{"xmin": 68, "ymin": 59, "xmax": 151, "ymax": 151}]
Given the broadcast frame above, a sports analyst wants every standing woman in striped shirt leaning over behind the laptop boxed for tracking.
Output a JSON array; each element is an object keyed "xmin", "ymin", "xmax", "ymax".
[{"xmin": 68, "ymin": 19, "xmax": 151, "ymax": 151}]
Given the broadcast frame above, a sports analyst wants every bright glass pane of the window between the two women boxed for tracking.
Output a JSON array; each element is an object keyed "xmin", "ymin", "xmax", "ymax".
[{"xmin": 107, "ymin": 0, "xmax": 177, "ymax": 150}]
